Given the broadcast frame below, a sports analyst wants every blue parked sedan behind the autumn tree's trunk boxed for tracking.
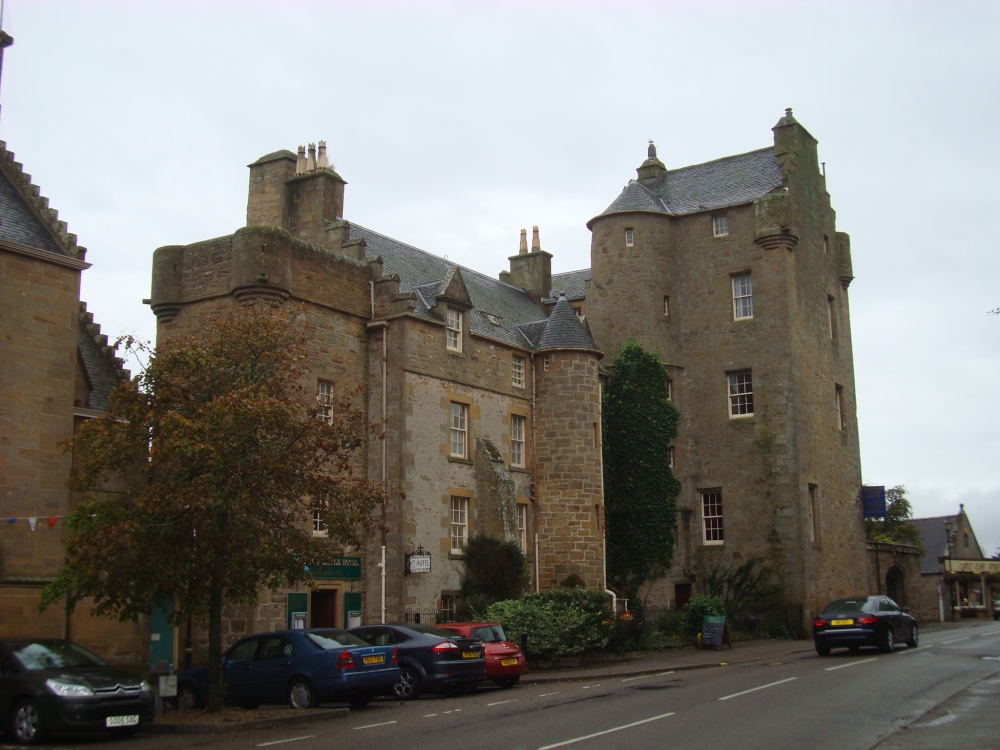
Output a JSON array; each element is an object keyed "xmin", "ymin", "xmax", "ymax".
[{"xmin": 176, "ymin": 628, "xmax": 399, "ymax": 709}]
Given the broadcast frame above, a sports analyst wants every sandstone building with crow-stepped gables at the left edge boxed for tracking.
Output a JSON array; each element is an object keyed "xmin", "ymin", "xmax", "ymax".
[{"xmin": 0, "ymin": 32, "xmax": 139, "ymax": 662}]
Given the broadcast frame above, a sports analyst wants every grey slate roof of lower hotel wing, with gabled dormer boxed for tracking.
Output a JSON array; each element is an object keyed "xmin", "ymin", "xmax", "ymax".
[{"xmin": 350, "ymin": 222, "xmax": 599, "ymax": 351}]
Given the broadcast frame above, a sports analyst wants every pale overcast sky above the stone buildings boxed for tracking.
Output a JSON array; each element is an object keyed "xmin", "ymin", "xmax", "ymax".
[{"xmin": 0, "ymin": 0, "xmax": 1000, "ymax": 555}]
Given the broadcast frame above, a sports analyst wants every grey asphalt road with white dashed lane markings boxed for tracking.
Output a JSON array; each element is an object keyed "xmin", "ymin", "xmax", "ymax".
[{"xmin": 13, "ymin": 622, "xmax": 1000, "ymax": 750}]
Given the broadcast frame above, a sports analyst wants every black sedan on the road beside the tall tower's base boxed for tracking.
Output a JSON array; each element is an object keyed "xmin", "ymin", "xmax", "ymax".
[{"xmin": 813, "ymin": 595, "xmax": 917, "ymax": 656}]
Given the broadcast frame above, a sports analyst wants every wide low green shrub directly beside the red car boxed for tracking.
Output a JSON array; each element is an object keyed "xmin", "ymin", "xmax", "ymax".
[{"xmin": 486, "ymin": 588, "xmax": 609, "ymax": 660}]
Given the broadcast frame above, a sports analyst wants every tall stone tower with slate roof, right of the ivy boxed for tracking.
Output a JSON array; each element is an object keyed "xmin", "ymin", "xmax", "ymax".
[{"xmin": 584, "ymin": 112, "xmax": 866, "ymax": 621}]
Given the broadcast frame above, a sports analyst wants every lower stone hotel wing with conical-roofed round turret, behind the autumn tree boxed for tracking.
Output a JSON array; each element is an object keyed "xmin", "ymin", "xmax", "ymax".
[{"xmin": 148, "ymin": 144, "xmax": 604, "ymax": 656}]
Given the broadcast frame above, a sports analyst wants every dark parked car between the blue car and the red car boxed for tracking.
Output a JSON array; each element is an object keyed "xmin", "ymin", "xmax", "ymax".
[{"xmin": 351, "ymin": 624, "xmax": 486, "ymax": 700}]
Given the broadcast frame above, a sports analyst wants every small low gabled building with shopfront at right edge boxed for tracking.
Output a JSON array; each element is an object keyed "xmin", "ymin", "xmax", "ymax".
[{"xmin": 910, "ymin": 504, "xmax": 1000, "ymax": 620}]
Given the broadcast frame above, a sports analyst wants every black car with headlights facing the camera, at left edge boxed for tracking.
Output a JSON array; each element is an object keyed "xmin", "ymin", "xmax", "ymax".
[{"xmin": 0, "ymin": 638, "xmax": 154, "ymax": 745}]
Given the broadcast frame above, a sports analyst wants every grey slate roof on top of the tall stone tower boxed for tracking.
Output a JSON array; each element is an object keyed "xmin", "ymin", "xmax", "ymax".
[{"xmin": 588, "ymin": 148, "xmax": 782, "ymax": 226}]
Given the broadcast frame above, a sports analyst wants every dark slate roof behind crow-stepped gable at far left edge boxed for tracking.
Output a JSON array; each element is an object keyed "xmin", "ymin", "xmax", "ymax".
[{"xmin": 0, "ymin": 141, "xmax": 87, "ymax": 260}]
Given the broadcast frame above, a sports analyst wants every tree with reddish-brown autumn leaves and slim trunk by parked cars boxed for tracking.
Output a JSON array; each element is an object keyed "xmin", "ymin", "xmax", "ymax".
[{"xmin": 43, "ymin": 305, "xmax": 384, "ymax": 710}]
